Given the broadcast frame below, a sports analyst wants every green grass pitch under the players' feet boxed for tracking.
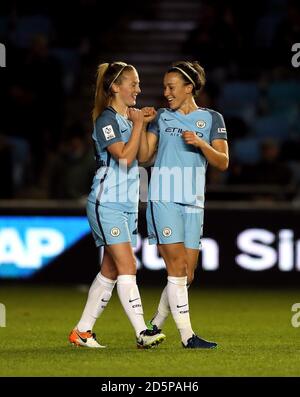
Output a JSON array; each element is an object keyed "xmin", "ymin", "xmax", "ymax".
[{"xmin": 0, "ymin": 286, "xmax": 300, "ymax": 376}]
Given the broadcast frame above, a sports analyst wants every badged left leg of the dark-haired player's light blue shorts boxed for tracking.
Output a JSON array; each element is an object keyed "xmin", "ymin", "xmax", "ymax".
[{"xmin": 146, "ymin": 201, "xmax": 184, "ymax": 245}]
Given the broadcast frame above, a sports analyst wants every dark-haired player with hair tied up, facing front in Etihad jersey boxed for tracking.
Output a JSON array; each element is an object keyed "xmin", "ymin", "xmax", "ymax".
[{"xmin": 139, "ymin": 61, "xmax": 229, "ymax": 349}]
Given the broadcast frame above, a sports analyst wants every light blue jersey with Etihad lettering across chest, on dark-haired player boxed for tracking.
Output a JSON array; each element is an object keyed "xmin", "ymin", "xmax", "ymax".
[{"xmin": 148, "ymin": 108, "xmax": 227, "ymax": 208}]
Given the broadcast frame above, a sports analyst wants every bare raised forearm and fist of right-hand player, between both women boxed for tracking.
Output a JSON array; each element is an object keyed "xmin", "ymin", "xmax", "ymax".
[{"xmin": 138, "ymin": 108, "xmax": 158, "ymax": 163}]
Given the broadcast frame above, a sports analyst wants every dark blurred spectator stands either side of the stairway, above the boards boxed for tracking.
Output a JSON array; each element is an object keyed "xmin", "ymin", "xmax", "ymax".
[{"xmin": 0, "ymin": 0, "xmax": 300, "ymax": 200}]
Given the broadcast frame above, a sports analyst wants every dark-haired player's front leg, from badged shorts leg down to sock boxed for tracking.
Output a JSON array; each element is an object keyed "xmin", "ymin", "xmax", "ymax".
[{"xmin": 147, "ymin": 202, "xmax": 194, "ymax": 343}]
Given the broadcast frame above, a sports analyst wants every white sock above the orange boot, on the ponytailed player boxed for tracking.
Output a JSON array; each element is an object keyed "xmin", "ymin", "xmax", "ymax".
[{"xmin": 77, "ymin": 273, "xmax": 117, "ymax": 332}]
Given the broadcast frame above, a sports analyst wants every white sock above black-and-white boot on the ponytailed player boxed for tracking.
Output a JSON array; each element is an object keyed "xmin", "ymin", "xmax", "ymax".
[{"xmin": 117, "ymin": 275, "xmax": 147, "ymax": 336}]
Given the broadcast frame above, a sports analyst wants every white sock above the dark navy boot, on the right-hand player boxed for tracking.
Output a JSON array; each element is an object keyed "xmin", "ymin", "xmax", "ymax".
[{"xmin": 167, "ymin": 276, "xmax": 194, "ymax": 345}]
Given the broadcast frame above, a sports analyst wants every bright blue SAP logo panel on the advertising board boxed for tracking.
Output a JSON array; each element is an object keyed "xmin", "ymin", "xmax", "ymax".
[{"xmin": 0, "ymin": 216, "xmax": 90, "ymax": 278}]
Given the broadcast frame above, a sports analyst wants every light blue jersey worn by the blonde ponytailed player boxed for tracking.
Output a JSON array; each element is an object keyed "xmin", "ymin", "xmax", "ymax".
[{"xmin": 88, "ymin": 107, "xmax": 139, "ymax": 212}]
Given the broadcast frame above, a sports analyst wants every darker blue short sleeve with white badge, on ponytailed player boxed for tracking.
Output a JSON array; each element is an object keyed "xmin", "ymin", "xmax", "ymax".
[{"xmin": 95, "ymin": 113, "xmax": 123, "ymax": 149}]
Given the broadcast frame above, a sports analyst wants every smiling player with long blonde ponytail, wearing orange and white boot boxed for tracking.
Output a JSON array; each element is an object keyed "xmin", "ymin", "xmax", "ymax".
[{"xmin": 69, "ymin": 62, "xmax": 165, "ymax": 348}]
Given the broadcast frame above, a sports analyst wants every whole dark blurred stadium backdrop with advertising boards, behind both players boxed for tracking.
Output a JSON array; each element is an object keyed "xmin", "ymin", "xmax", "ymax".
[{"xmin": 0, "ymin": 0, "xmax": 300, "ymax": 374}]
